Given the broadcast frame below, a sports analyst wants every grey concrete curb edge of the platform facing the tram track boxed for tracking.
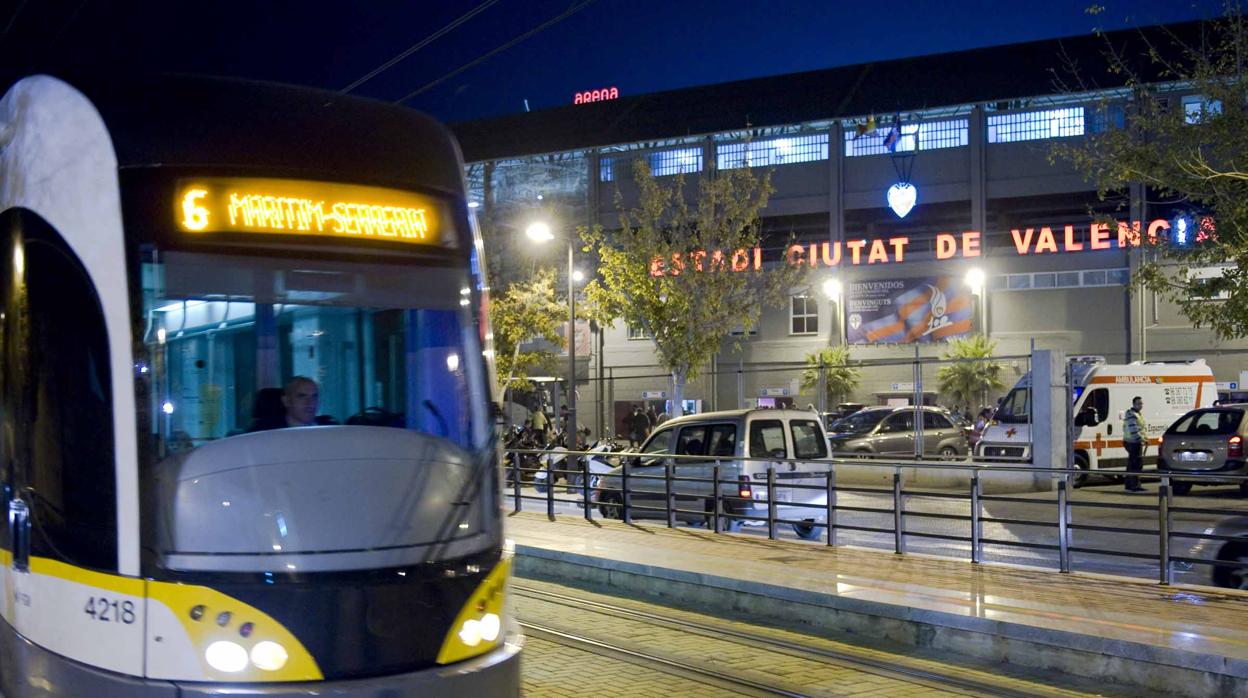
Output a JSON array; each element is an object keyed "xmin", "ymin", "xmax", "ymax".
[{"xmin": 515, "ymin": 544, "xmax": 1248, "ymax": 698}]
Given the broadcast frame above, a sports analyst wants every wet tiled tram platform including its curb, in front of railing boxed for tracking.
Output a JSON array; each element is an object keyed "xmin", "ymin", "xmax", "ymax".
[{"xmin": 508, "ymin": 513, "xmax": 1248, "ymax": 696}]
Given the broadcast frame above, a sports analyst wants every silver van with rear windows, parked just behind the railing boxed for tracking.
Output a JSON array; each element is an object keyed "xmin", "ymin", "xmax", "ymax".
[{"xmin": 594, "ymin": 410, "xmax": 831, "ymax": 539}]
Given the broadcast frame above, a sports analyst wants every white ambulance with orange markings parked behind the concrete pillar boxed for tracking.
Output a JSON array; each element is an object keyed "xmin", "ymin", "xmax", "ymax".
[{"xmin": 975, "ymin": 356, "xmax": 1218, "ymax": 484}]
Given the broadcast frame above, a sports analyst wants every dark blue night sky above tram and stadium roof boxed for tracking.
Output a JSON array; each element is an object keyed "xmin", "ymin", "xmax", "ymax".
[{"xmin": 0, "ymin": 0, "xmax": 1223, "ymax": 121}]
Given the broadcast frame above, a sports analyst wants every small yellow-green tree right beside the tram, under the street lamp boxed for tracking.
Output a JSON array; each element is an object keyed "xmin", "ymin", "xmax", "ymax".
[{"xmin": 490, "ymin": 270, "xmax": 568, "ymax": 392}]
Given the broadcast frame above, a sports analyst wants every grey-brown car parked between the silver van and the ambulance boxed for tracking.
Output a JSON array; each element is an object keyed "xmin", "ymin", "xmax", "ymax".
[{"xmin": 827, "ymin": 406, "xmax": 970, "ymax": 458}]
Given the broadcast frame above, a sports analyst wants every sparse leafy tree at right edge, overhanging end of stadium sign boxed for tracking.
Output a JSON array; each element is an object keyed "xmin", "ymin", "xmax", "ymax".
[{"xmin": 1052, "ymin": 4, "xmax": 1248, "ymax": 340}]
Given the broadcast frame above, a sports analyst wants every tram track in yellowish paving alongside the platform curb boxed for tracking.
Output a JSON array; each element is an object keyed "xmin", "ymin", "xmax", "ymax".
[{"xmin": 512, "ymin": 582, "xmax": 1071, "ymax": 698}]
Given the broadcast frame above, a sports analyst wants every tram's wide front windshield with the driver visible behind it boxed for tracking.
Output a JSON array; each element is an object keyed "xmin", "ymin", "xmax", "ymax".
[{"xmin": 140, "ymin": 252, "xmax": 487, "ymax": 457}]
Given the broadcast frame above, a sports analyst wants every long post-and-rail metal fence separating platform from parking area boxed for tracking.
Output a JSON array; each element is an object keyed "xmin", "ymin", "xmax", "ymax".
[{"xmin": 505, "ymin": 450, "xmax": 1248, "ymax": 588}]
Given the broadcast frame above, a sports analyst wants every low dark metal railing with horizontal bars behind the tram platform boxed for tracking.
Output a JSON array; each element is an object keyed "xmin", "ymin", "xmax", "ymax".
[{"xmin": 504, "ymin": 450, "xmax": 1248, "ymax": 584}]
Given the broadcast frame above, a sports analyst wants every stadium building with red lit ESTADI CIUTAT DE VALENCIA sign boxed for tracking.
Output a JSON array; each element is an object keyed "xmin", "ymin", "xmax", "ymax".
[{"xmin": 454, "ymin": 24, "xmax": 1248, "ymax": 431}]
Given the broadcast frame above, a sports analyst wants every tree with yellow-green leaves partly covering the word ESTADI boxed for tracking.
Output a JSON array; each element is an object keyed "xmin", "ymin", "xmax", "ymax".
[{"xmin": 579, "ymin": 159, "xmax": 802, "ymax": 415}]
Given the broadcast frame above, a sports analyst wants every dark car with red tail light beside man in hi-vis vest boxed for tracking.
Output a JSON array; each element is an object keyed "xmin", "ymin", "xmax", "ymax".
[{"xmin": 1157, "ymin": 403, "xmax": 1248, "ymax": 496}]
